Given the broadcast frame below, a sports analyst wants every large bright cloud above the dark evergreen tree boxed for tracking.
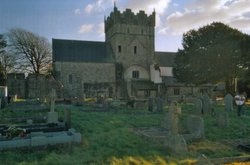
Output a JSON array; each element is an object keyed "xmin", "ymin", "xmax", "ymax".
[{"xmin": 159, "ymin": 0, "xmax": 250, "ymax": 35}]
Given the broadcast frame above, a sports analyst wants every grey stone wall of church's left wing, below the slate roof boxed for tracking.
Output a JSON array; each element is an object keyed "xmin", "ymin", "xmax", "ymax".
[{"xmin": 54, "ymin": 62, "xmax": 116, "ymax": 98}]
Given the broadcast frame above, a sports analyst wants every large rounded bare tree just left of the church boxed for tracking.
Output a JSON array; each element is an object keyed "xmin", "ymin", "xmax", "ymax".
[{"xmin": 8, "ymin": 29, "xmax": 52, "ymax": 74}]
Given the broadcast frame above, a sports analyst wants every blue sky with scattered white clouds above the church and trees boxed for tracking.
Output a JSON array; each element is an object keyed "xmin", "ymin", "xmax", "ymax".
[{"xmin": 0, "ymin": 0, "xmax": 250, "ymax": 52}]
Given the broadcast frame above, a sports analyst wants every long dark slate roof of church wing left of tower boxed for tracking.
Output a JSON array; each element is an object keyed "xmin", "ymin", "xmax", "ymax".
[{"xmin": 52, "ymin": 39, "xmax": 114, "ymax": 63}]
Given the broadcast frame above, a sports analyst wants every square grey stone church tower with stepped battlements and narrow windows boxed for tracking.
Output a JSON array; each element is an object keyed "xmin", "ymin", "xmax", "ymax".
[{"xmin": 105, "ymin": 6, "xmax": 155, "ymax": 96}]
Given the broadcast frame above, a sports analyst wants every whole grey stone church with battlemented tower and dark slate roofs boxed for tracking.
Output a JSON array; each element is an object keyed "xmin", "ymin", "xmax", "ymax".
[{"xmin": 52, "ymin": 6, "xmax": 214, "ymax": 98}]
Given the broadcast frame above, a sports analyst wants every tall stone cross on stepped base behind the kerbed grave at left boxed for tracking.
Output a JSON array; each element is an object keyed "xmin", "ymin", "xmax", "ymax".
[{"xmin": 47, "ymin": 88, "xmax": 58, "ymax": 123}]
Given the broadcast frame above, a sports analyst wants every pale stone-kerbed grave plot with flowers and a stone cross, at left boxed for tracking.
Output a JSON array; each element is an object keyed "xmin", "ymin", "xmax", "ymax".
[{"xmin": 0, "ymin": 90, "xmax": 81, "ymax": 150}]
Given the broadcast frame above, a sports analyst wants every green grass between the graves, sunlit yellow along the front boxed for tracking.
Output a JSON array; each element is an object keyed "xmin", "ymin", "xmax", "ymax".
[{"xmin": 0, "ymin": 104, "xmax": 250, "ymax": 165}]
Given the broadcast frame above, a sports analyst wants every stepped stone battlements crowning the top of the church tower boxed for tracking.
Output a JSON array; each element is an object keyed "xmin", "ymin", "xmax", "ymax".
[{"xmin": 105, "ymin": 6, "xmax": 155, "ymax": 32}]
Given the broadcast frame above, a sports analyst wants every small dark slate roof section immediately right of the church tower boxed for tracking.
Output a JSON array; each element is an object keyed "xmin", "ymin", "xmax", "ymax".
[{"xmin": 155, "ymin": 52, "xmax": 176, "ymax": 67}]
